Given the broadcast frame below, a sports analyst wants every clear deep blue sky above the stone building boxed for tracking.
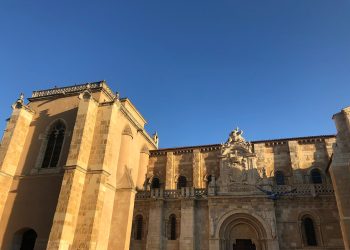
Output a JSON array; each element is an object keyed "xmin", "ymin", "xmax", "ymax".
[{"xmin": 0, "ymin": 0, "xmax": 350, "ymax": 147}]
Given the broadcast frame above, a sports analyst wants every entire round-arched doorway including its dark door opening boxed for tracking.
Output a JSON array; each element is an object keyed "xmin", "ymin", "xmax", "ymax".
[{"xmin": 218, "ymin": 213, "xmax": 268, "ymax": 250}]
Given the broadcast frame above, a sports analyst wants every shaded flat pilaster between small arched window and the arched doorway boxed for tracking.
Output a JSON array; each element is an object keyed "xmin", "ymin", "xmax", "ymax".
[{"xmin": 180, "ymin": 199, "xmax": 195, "ymax": 250}]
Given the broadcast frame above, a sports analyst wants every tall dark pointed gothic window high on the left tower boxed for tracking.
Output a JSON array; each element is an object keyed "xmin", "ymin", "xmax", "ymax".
[{"xmin": 41, "ymin": 121, "xmax": 66, "ymax": 168}]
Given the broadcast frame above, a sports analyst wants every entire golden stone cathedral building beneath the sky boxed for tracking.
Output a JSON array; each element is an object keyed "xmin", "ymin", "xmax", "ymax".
[{"xmin": 0, "ymin": 81, "xmax": 350, "ymax": 250}]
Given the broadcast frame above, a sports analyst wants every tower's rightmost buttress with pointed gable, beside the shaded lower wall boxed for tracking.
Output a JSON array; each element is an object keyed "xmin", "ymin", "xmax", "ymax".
[{"xmin": 108, "ymin": 125, "xmax": 135, "ymax": 250}]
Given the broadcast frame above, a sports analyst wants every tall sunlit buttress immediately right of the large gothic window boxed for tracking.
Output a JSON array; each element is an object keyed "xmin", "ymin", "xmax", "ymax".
[{"xmin": 47, "ymin": 91, "xmax": 98, "ymax": 250}]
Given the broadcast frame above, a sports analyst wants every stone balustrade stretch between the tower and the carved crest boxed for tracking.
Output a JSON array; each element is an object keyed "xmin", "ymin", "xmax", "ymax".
[{"xmin": 136, "ymin": 187, "xmax": 207, "ymax": 199}]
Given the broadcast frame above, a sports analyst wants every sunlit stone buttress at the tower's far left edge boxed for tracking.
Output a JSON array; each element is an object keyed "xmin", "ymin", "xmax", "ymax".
[{"xmin": 0, "ymin": 100, "xmax": 34, "ymax": 219}]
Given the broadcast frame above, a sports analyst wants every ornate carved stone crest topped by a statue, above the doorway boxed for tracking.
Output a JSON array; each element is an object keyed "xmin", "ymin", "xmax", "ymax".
[{"xmin": 218, "ymin": 128, "xmax": 260, "ymax": 193}]
